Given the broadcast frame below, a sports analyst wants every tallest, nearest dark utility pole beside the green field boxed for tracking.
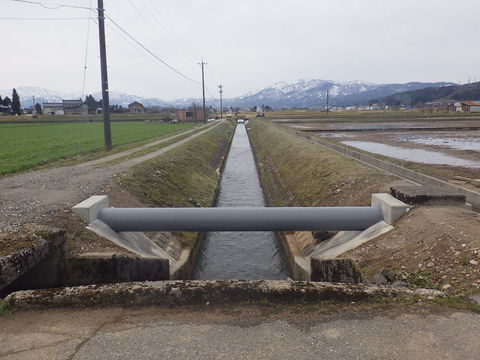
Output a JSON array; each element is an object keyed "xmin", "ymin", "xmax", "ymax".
[{"xmin": 98, "ymin": 0, "xmax": 112, "ymax": 151}]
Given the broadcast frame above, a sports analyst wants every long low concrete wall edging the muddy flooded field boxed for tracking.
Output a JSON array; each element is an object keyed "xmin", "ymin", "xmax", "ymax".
[{"xmin": 300, "ymin": 134, "xmax": 480, "ymax": 212}]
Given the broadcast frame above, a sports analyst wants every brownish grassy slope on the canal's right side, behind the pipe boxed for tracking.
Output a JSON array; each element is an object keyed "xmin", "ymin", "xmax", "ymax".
[{"xmin": 249, "ymin": 120, "xmax": 398, "ymax": 206}]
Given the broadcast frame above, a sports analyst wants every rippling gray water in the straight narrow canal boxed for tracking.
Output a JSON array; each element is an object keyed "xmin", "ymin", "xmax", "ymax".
[{"xmin": 194, "ymin": 123, "xmax": 287, "ymax": 280}]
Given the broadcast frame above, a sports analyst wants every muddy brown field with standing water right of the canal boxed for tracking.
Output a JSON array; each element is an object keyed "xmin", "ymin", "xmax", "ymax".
[{"xmin": 288, "ymin": 120, "xmax": 480, "ymax": 183}]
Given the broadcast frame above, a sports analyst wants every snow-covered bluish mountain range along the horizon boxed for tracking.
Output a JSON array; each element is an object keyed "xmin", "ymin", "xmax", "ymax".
[{"xmin": 0, "ymin": 80, "xmax": 457, "ymax": 108}]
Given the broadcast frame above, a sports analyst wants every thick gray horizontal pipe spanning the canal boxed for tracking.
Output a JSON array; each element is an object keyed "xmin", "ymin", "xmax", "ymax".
[{"xmin": 98, "ymin": 207, "xmax": 383, "ymax": 231}]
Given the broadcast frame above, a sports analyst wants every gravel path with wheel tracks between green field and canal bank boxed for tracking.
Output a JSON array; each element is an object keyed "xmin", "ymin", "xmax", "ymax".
[{"xmin": 0, "ymin": 121, "xmax": 221, "ymax": 232}]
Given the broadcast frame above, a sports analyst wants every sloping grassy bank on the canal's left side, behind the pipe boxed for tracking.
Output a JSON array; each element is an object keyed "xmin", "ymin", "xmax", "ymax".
[{"xmin": 116, "ymin": 122, "xmax": 233, "ymax": 246}]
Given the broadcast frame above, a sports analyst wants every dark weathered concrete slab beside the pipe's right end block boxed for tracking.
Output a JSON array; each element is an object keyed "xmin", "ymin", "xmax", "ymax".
[{"xmin": 391, "ymin": 186, "xmax": 466, "ymax": 206}]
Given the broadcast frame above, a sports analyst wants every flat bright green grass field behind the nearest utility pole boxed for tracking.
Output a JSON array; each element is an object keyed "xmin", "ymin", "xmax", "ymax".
[{"xmin": 0, "ymin": 122, "xmax": 194, "ymax": 175}]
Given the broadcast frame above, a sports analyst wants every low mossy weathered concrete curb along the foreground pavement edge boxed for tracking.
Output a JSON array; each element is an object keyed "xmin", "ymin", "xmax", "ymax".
[{"xmin": 6, "ymin": 280, "xmax": 445, "ymax": 309}]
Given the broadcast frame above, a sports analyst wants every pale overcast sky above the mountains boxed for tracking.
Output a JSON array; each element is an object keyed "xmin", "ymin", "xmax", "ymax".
[{"xmin": 0, "ymin": 0, "xmax": 480, "ymax": 100}]
